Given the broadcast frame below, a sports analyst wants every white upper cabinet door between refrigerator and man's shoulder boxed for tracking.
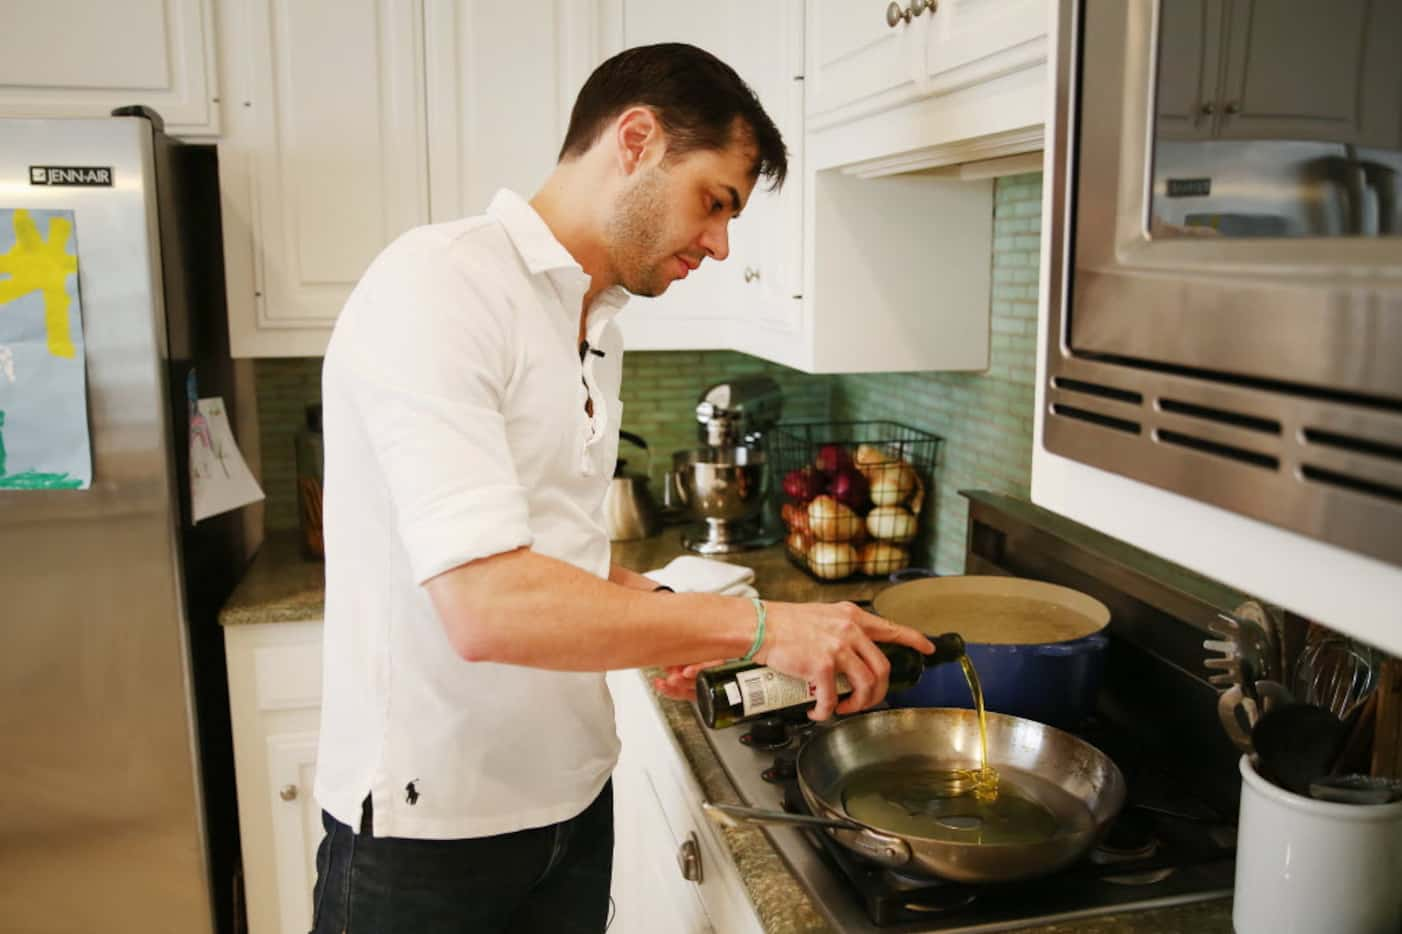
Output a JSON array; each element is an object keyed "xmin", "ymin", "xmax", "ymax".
[{"xmin": 219, "ymin": 0, "xmax": 429, "ymax": 356}]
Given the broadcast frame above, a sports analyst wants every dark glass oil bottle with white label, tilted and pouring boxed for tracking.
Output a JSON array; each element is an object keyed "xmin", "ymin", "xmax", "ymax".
[{"xmin": 697, "ymin": 632, "xmax": 965, "ymax": 729}]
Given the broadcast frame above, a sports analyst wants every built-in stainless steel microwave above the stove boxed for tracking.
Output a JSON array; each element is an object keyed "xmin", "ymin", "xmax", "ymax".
[{"xmin": 1040, "ymin": 0, "xmax": 1402, "ymax": 567}]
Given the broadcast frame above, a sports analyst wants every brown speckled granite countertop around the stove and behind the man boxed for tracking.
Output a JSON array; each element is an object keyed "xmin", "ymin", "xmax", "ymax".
[{"xmin": 219, "ymin": 527, "xmax": 1232, "ymax": 934}]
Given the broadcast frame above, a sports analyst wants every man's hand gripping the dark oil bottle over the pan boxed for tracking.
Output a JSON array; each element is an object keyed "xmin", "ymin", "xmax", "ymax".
[{"xmin": 754, "ymin": 603, "xmax": 935, "ymax": 719}]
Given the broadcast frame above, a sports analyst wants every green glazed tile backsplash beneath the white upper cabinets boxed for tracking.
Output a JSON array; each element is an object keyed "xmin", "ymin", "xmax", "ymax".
[{"xmin": 257, "ymin": 172, "xmax": 1042, "ymax": 560}]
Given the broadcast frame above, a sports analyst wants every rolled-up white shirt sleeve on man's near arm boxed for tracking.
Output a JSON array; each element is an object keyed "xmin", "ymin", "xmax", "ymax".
[{"xmin": 324, "ymin": 232, "xmax": 531, "ymax": 583}]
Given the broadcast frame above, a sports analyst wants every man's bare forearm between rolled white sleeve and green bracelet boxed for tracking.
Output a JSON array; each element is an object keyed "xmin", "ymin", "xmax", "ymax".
[{"xmin": 425, "ymin": 548, "xmax": 756, "ymax": 672}]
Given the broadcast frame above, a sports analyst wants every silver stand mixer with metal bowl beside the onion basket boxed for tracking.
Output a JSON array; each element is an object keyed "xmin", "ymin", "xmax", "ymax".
[{"xmin": 672, "ymin": 376, "xmax": 784, "ymax": 554}]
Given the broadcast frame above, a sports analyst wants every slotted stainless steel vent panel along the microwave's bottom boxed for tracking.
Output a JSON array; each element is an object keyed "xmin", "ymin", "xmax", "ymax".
[{"xmin": 1043, "ymin": 355, "xmax": 1402, "ymax": 567}]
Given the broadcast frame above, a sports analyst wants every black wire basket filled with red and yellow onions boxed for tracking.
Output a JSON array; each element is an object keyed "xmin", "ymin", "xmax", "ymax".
[{"xmin": 768, "ymin": 421, "xmax": 944, "ymax": 581}]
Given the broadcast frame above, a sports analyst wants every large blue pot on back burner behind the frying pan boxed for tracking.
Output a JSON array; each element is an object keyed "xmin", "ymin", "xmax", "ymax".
[{"xmin": 872, "ymin": 575, "xmax": 1110, "ymax": 728}]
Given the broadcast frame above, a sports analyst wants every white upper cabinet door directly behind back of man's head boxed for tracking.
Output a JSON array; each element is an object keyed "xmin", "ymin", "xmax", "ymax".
[{"xmin": 425, "ymin": 0, "xmax": 600, "ymax": 222}]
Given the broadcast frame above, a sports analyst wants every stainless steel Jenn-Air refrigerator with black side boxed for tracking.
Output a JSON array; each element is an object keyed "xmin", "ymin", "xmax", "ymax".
[{"xmin": 0, "ymin": 108, "xmax": 244, "ymax": 934}]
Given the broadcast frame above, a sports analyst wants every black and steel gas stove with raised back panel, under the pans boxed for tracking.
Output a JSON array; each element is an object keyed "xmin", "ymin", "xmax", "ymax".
[{"xmin": 701, "ymin": 492, "xmax": 1245, "ymax": 934}]
